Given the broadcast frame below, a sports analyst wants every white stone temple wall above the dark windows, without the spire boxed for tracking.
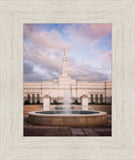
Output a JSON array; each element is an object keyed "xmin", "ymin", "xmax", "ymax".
[{"xmin": 24, "ymin": 81, "xmax": 112, "ymax": 104}]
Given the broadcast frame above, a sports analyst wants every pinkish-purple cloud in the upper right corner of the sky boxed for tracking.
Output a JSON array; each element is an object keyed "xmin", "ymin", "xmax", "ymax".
[{"xmin": 64, "ymin": 24, "xmax": 112, "ymax": 45}]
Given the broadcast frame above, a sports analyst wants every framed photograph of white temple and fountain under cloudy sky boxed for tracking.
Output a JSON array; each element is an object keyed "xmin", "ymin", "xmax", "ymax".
[{"xmin": 23, "ymin": 23, "xmax": 112, "ymax": 137}]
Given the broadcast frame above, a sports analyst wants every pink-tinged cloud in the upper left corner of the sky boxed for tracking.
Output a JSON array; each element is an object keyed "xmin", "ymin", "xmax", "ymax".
[{"xmin": 24, "ymin": 24, "xmax": 70, "ymax": 50}]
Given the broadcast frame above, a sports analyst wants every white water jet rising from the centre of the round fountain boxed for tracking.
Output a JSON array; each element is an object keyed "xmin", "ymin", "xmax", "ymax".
[{"xmin": 63, "ymin": 90, "xmax": 72, "ymax": 114}]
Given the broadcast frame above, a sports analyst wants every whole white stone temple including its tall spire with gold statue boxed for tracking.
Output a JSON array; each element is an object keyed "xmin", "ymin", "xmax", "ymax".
[{"xmin": 24, "ymin": 49, "xmax": 112, "ymax": 104}]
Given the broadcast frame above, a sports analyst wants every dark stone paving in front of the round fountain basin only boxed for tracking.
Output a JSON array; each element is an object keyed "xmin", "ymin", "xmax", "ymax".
[{"xmin": 24, "ymin": 115, "xmax": 111, "ymax": 136}]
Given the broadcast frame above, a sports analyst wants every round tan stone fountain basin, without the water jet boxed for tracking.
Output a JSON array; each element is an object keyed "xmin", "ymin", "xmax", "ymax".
[{"xmin": 28, "ymin": 110, "xmax": 107, "ymax": 127}]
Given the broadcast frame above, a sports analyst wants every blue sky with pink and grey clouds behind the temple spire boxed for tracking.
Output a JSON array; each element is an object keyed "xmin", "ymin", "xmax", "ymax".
[{"xmin": 23, "ymin": 24, "xmax": 112, "ymax": 82}]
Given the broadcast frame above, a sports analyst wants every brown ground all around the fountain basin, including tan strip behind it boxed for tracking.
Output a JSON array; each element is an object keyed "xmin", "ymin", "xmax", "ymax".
[{"xmin": 24, "ymin": 105, "xmax": 112, "ymax": 136}]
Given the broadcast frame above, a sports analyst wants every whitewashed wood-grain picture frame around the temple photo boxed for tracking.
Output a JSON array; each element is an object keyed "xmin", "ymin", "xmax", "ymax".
[{"xmin": 0, "ymin": 0, "xmax": 135, "ymax": 160}]
